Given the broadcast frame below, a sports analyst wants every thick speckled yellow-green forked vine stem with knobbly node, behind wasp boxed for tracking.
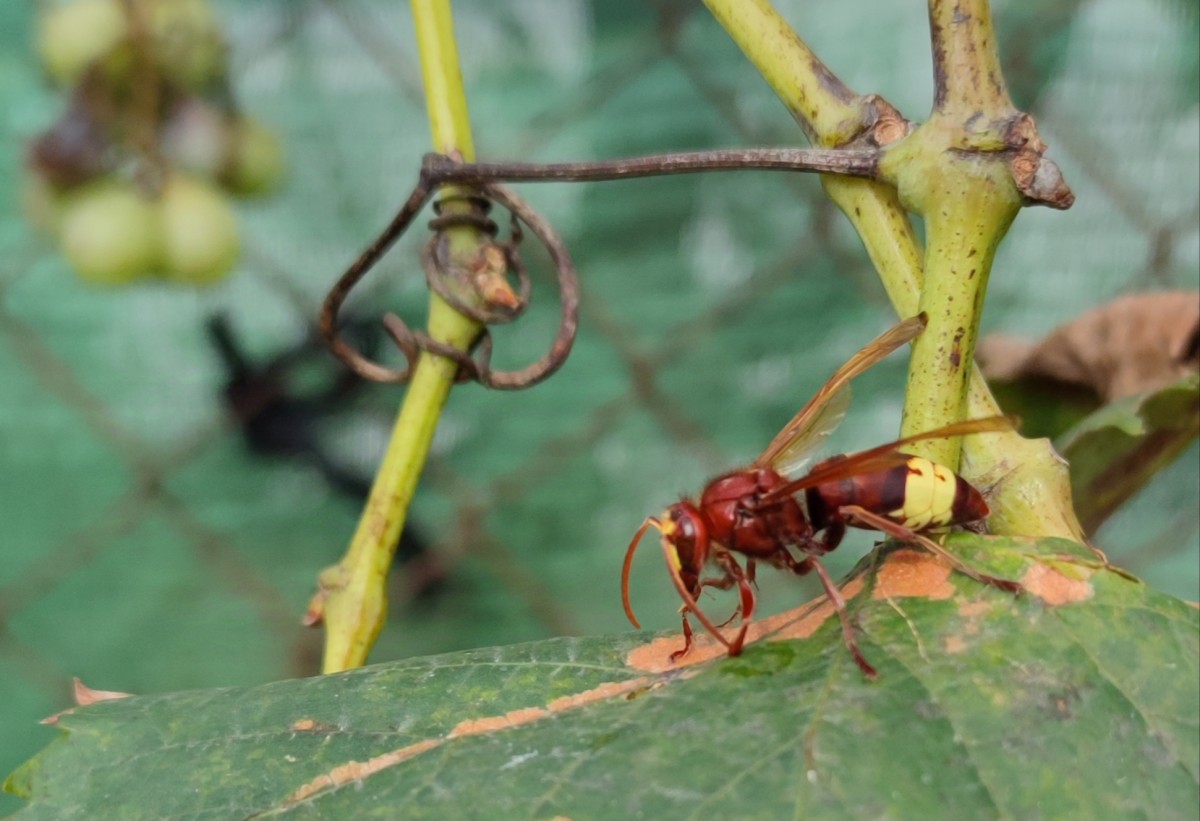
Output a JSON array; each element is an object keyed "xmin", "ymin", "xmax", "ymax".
[{"xmin": 704, "ymin": 0, "xmax": 1084, "ymax": 541}]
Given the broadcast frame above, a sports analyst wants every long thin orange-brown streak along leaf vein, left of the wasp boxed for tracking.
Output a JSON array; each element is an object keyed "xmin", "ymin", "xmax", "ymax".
[{"xmin": 271, "ymin": 677, "xmax": 653, "ymax": 809}]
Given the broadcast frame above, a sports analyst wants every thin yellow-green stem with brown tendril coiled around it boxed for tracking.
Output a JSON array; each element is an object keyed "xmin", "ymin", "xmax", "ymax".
[{"xmin": 305, "ymin": 0, "xmax": 496, "ymax": 673}]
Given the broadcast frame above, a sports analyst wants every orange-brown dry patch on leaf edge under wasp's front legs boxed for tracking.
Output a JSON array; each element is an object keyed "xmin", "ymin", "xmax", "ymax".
[{"xmin": 625, "ymin": 576, "xmax": 863, "ymax": 673}]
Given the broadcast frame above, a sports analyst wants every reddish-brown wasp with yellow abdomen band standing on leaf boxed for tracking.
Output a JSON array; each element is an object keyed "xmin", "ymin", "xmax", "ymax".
[{"xmin": 620, "ymin": 314, "xmax": 1021, "ymax": 678}]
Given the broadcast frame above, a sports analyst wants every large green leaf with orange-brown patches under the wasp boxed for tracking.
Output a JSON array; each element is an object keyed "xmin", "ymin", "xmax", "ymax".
[{"xmin": 7, "ymin": 534, "xmax": 1200, "ymax": 819}]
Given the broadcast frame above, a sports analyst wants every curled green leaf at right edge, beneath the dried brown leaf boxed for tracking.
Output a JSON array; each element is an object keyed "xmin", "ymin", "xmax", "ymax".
[{"xmin": 1057, "ymin": 374, "xmax": 1200, "ymax": 533}]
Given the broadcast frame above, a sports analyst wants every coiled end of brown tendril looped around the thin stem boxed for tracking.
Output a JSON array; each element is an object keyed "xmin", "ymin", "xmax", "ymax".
[{"xmin": 319, "ymin": 165, "xmax": 580, "ymax": 390}]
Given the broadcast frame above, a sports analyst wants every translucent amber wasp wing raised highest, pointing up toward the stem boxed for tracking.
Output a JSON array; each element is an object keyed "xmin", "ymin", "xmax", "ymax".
[{"xmin": 754, "ymin": 314, "xmax": 925, "ymax": 474}]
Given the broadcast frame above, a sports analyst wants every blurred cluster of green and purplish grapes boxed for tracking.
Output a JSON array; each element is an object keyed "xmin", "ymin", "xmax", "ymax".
[{"xmin": 25, "ymin": 0, "xmax": 284, "ymax": 284}]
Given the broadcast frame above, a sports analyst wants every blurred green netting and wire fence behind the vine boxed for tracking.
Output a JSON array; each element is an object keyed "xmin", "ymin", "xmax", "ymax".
[{"xmin": 0, "ymin": 0, "xmax": 1200, "ymax": 810}]
